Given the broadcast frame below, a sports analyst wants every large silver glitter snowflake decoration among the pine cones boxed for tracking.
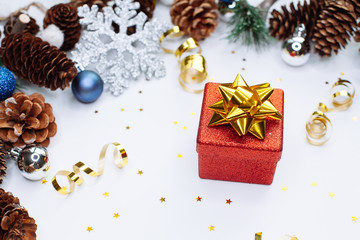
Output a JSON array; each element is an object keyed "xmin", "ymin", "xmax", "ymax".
[{"xmin": 72, "ymin": 0, "xmax": 167, "ymax": 96}]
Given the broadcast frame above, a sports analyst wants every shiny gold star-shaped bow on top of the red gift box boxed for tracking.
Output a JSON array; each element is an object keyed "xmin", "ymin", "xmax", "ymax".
[{"xmin": 209, "ymin": 74, "xmax": 282, "ymax": 139}]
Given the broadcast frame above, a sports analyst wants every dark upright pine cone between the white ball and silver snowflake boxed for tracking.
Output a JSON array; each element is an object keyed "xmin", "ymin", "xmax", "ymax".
[{"xmin": 44, "ymin": 3, "xmax": 81, "ymax": 51}]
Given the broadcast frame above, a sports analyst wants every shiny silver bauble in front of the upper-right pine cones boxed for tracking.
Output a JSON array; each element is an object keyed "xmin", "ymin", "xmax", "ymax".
[{"xmin": 281, "ymin": 24, "xmax": 310, "ymax": 67}]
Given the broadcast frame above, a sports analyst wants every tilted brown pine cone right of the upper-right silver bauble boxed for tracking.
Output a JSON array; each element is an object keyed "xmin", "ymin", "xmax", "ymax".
[{"xmin": 312, "ymin": 0, "xmax": 357, "ymax": 57}]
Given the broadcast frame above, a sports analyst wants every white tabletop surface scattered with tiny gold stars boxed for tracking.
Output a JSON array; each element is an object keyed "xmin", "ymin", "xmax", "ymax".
[{"xmin": 0, "ymin": 0, "xmax": 360, "ymax": 240}]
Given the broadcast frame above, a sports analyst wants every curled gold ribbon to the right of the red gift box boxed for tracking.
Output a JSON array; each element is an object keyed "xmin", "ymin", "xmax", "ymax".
[{"xmin": 306, "ymin": 78, "xmax": 355, "ymax": 146}]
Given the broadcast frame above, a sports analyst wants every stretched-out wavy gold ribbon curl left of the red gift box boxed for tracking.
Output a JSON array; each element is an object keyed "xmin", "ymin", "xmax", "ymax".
[{"xmin": 52, "ymin": 142, "xmax": 128, "ymax": 195}]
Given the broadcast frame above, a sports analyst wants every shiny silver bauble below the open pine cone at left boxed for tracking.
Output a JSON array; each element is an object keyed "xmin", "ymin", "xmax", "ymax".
[{"xmin": 10, "ymin": 146, "xmax": 50, "ymax": 181}]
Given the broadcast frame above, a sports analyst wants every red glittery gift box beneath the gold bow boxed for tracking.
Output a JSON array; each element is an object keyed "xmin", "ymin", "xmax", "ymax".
[{"xmin": 197, "ymin": 83, "xmax": 284, "ymax": 185}]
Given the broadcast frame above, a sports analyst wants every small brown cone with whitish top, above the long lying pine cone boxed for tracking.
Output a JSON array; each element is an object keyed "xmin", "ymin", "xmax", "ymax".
[{"xmin": 4, "ymin": 13, "xmax": 40, "ymax": 36}]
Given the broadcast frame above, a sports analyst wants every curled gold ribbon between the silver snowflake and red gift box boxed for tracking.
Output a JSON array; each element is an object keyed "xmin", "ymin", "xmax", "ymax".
[{"xmin": 160, "ymin": 26, "xmax": 208, "ymax": 93}]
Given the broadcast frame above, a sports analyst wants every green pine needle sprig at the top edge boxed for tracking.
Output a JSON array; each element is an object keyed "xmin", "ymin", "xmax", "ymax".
[{"xmin": 228, "ymin": 0, "xmax": 271, "ymax": 48}]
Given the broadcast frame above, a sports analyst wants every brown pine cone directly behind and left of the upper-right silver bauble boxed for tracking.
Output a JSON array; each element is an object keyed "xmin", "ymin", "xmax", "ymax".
[{"xmin": 269, "ymin": 0, "xmax": 323, "ymax": 40}]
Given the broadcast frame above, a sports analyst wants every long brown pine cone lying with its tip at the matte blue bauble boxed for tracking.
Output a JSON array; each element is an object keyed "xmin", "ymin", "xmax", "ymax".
[{"xmin": 0, "ymin": 33, "xmax": 77, "ymax": 90}]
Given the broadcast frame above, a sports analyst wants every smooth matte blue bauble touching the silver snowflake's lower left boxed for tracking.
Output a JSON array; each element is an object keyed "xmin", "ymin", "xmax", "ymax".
[{"xmin": 71, "ymin": 70, "xmax": 104, "ymax": 103}]
